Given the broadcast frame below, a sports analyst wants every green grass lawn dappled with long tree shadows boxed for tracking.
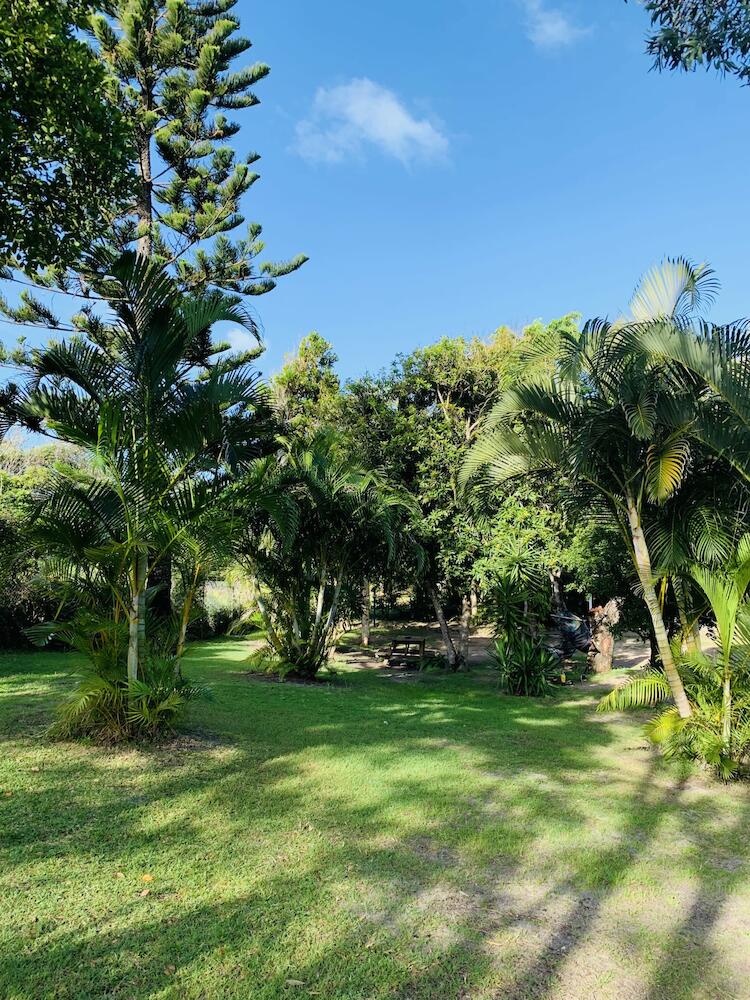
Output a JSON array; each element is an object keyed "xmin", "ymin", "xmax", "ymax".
[{"xmin": 0, "ymin": 641, "xmax": 750, "ymax": 1000}]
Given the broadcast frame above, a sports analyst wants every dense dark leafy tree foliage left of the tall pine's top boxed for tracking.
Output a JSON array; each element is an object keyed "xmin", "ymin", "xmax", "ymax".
[{"xmin": 0, "ymin": 0, "xmax": 132, "ymax": 269}]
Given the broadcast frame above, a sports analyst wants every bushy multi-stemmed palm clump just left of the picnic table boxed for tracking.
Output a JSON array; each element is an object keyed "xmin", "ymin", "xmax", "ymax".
[{"xmin": 235, "ymin": 430, "xmax": 413, "ymax": 677}]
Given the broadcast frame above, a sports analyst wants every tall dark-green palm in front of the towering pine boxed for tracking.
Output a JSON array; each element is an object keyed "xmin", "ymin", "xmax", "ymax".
[{"xmin": 5, "ymin": 253, "xmax": 263, "ymax": 681}]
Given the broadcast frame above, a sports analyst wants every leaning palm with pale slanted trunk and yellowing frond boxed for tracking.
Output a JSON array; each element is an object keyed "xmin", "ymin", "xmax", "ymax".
[{"xmin": 463, "ymin": 260, "xmax": 715, "ymax": 718}]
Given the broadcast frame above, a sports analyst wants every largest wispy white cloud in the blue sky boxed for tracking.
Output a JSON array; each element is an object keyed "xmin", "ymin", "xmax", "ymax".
[{"xmin": 295, "ymin": 77, "xmax": 448, "ymax": 164}]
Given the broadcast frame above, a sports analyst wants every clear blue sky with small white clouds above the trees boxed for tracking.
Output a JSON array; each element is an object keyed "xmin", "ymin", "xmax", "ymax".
[{"xmin": 4, "ymin": 0, "xmax": 750, "ymax": 376}]
